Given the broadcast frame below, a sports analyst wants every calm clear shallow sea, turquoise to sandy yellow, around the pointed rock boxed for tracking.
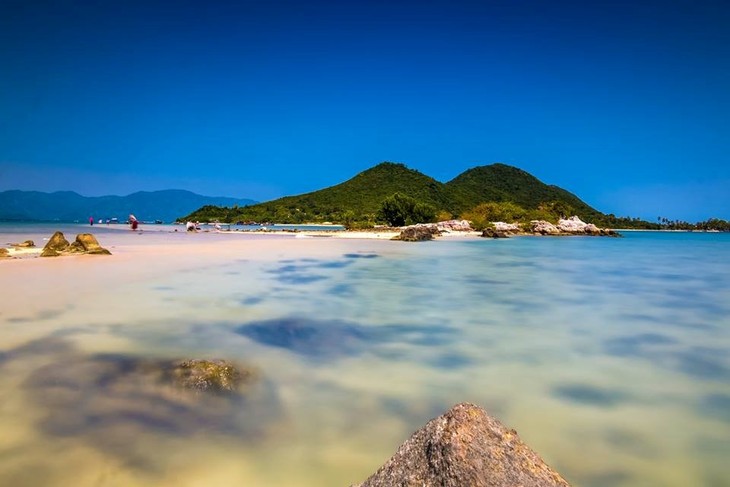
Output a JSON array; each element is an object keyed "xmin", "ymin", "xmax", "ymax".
[{"xmin": 0, "ymin": 225, "xmax": 730, "ymax": 487}]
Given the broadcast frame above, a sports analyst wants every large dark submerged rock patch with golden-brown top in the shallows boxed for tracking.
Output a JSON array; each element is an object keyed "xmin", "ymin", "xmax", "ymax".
[{"xmin": 14, "ymin": 338, "xmax": 282, "ymax": 458}]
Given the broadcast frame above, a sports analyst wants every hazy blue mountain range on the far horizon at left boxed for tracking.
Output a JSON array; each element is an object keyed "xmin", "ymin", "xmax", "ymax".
[{"xmin": 0, "ymin": 189, "xmax": 256, "ymax": 223}]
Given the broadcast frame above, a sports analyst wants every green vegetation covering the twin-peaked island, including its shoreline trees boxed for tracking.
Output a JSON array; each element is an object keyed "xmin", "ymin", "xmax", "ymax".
[{"xmin": 180, "ymin": 162, "xmax": 724, "ymax": 229}]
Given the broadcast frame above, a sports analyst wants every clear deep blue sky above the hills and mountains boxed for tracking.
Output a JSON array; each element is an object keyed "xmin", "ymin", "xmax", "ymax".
[{"xmin": 0, "ymin": 0, "xmax": 730, "ymax": 221}]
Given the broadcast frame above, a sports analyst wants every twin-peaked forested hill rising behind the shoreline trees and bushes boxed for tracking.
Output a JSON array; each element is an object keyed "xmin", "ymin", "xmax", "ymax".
[{"xmin": 180, "ymin": 162, "xmax": 607, "ymax": 223}]
